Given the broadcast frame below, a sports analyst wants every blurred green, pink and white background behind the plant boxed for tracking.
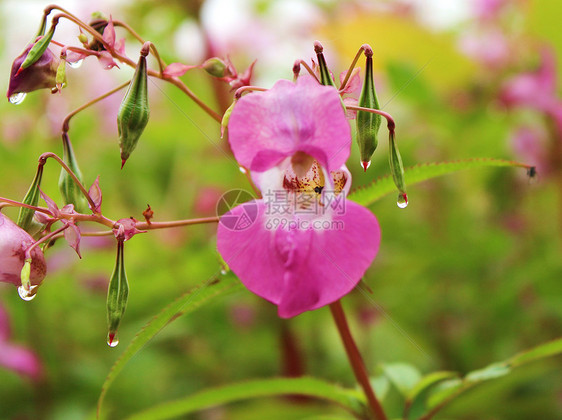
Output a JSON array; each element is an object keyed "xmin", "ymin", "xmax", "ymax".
[{"xmin": 0, "ymin": 0, "xmax": 562, "ymax": 420}]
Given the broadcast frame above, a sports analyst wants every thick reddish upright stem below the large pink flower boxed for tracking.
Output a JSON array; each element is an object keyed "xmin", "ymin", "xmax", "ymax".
[{"xmin": 330, "ymin": 300, "xmax": 387, "ymax": 420}]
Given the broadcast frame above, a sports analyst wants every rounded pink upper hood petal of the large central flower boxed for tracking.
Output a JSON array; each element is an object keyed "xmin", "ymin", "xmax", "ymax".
[{"xmin": 228, "ymin": 77, "xmax": 351, "ymax": 171}]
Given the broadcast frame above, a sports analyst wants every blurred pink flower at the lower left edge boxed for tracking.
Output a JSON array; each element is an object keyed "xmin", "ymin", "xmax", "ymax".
[{"xmin": 0, "ymin": 304, "xmax": 42, "ymax": 381}]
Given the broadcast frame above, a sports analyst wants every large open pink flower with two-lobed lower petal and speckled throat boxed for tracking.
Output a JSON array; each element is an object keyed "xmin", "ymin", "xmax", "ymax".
[{"xmin": 217, "ymin": 77, "xmax": 380, "ymax": 318}]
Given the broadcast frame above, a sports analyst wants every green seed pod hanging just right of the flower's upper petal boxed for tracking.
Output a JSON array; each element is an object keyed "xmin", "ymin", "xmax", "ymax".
[{"xmin": 357, "ymin": 45, "xmax": 382, "ymax": 171}]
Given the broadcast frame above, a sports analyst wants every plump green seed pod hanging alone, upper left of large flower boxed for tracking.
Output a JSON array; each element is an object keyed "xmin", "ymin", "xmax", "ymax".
[{"xmin": 117, "ymin": 42, "xmax": 150, "ymax": 168}]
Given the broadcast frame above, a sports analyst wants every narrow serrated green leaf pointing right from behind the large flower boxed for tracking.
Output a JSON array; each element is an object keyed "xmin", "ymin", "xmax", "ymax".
[{"xmin": 349, "ymin": 158, "xmax": 531, "ymax": 206}]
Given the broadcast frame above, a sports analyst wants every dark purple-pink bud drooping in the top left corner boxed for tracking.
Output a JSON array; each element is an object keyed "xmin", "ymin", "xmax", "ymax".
[{"xmin": 6, "ymin": 44, "xmax": 59, "ymax": 98}]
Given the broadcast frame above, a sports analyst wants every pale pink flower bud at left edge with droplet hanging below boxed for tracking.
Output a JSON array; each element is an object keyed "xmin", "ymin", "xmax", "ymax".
[{"xmin": 0, "ymin": 213, "xmax": 47, "ymax": 286}]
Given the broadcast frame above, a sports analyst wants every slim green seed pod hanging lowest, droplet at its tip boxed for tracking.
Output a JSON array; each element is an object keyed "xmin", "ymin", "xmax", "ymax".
[{"xmin": 107, "ymin": 238, "xmax": 129, "ymax": 347}]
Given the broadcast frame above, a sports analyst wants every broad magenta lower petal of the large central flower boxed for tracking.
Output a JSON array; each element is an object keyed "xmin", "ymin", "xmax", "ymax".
[{"xmin": 217, "ymin": 200, "xmax": 380, "ymax": 318}]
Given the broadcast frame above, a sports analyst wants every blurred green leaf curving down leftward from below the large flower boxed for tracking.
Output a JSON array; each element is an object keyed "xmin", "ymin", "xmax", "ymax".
[{"xmin": 97, "ymin": 274, "xmax": 242, "ymax": 418}]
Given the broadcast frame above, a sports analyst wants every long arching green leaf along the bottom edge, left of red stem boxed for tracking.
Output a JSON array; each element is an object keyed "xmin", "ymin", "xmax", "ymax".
[{"xmin": 124, "ymin": 377, "xmax": 364, "ymax": 420}]
